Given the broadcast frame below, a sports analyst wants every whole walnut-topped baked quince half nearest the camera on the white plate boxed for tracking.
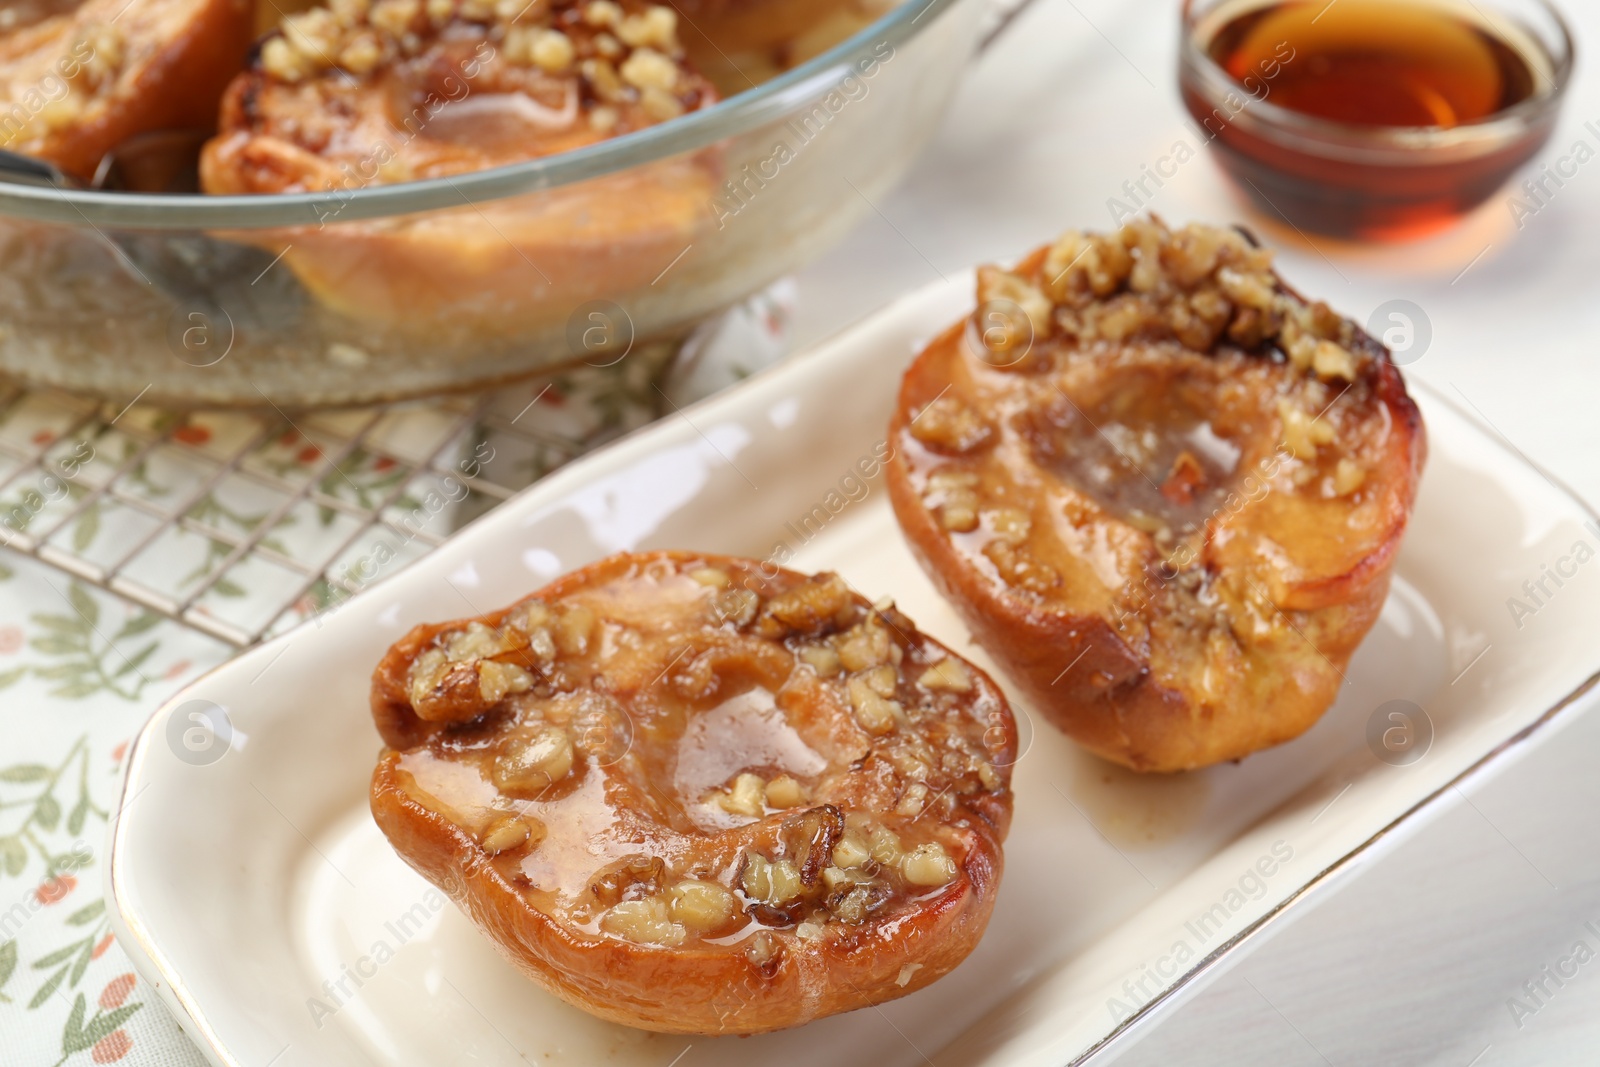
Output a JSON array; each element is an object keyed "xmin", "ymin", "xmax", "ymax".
[{"xmin": 371, "ymin": 552, "xmax": 1016, "ymax": 1033}]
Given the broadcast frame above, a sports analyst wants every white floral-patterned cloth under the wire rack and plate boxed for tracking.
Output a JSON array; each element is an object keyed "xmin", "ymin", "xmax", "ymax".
[{"xmin": 0, "ymin": 283, "xmax": 794, "ymax": 1067}]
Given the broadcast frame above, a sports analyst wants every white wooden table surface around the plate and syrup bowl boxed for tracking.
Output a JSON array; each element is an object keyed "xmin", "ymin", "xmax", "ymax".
[{"xmin": 798, "ymin": 0, "xmax": 1600, "ymax": 1067}]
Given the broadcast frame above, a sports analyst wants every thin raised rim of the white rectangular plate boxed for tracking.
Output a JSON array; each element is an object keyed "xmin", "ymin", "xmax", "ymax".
[{"xmin": 104, "ymin": 278, "xmax": 1600, "ymax": 1067}]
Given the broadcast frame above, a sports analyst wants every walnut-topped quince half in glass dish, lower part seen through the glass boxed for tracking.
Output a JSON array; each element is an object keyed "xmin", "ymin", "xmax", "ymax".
[{"xmin": 200, "ymin": 0, "xmax": 718, "ymax": 336}]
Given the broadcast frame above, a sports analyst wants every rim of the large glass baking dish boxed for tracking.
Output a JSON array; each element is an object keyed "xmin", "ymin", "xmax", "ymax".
[{"xmin": 0, "ymin": 0, "xmax": 953, "ymax": 230}]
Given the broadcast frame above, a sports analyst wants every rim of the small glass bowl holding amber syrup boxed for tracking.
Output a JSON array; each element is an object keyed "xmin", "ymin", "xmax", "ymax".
[{"xmin": 1179, "ymin": 0, "xmax": 1578, "ymax": 154}]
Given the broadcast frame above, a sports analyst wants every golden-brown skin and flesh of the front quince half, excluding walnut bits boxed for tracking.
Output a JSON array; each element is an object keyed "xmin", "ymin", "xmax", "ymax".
[{"xmin": 371, "ymin": 552, "xmax": 1016, "ymax": 1033}]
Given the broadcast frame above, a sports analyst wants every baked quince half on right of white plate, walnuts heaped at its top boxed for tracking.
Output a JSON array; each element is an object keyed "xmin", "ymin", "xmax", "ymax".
[{"xmin": 888, "ymin": 219, "xmax": 1426, "ymax": 771}]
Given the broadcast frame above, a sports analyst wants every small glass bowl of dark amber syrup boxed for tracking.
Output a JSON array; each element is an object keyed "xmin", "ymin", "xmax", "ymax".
[{"xmin": 1179, "ymin": 0, "xmax": 1573, "ymax": 240}]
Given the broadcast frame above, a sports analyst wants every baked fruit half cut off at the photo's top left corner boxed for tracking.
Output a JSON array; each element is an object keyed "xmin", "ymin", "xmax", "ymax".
[{"xmin": 0, "ymin": 0, "xmax": 254, "ymax": 181}]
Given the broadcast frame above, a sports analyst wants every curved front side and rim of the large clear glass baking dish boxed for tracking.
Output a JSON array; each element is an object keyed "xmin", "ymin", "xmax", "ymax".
[{"xmin": 0, "ymin": 0, "xmax": 982, "ymax": 408}]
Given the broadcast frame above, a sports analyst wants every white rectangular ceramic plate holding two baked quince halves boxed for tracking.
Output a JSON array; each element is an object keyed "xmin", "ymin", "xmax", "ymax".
[{"xmin": 109, "ymin": 277, "xmax": 1600, "ymax": 1067}]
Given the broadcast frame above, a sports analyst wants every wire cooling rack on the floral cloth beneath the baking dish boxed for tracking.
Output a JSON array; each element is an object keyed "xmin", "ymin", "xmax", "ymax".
[{"xmin": 0, "ymin": 365, "xmax": 664, "ymax": 648}]
